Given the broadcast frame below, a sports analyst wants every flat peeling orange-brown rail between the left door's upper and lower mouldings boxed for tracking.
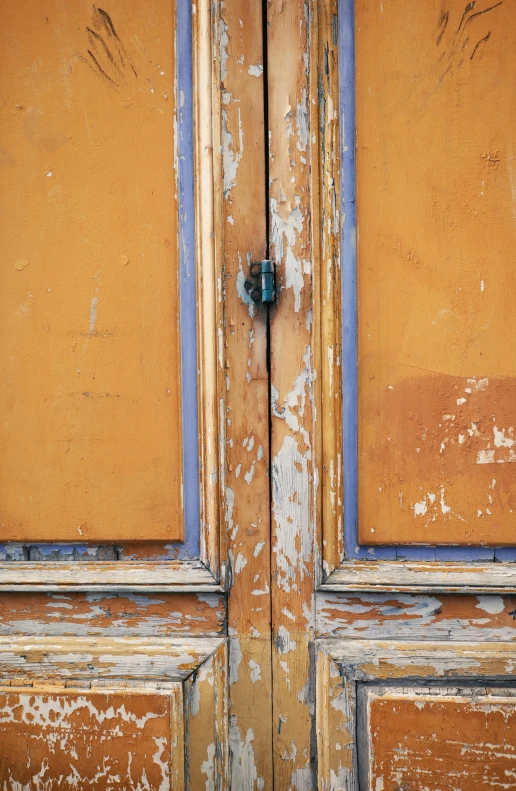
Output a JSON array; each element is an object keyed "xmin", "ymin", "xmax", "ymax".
[{"xmin": 0, "ymin": 591, "xmax": 226, "ymax": 637}]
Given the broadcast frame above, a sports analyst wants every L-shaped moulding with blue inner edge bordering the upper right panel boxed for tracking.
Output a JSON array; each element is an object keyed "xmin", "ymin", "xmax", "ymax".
[{"xmin": 312, "ymin": 0, "xmax": 516, "ymax": 592}]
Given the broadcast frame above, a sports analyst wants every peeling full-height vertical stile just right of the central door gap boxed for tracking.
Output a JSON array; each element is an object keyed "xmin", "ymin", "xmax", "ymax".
[{"xmin": 268, "ymin": 0, "xmax": 338, "ymax": 789}]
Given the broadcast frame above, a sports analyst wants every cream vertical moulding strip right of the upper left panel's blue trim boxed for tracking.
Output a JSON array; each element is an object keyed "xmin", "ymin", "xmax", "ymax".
[{"xmin": 192, "ymin": 0, "xmax": 225, "ymax": 578}]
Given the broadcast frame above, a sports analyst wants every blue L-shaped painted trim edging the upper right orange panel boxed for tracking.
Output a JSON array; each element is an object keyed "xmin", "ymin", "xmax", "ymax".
[{"xmin": 339, "ymin": 0, "xmax": 516, "ymax": 562}]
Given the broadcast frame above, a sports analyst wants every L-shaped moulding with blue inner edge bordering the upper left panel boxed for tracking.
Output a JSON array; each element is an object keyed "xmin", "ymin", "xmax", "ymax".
[{"xmin": 0, "ymin": 2, "xmax": 223, "ymax": 590}]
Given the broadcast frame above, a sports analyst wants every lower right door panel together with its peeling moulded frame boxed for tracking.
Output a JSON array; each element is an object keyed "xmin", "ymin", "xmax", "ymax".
[{"xmin": 317, "ymin": 640, "xmax": 516, "ymax": 791}]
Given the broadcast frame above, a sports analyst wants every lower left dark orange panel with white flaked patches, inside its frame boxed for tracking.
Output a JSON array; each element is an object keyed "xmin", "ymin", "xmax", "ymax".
[{"xmin": 0, "ymin": 685, "xmax": 184, "ymax": 791}]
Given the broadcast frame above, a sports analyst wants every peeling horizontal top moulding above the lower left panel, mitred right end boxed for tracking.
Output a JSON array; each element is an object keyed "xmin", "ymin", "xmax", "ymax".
[{"xmin": 0, "ymin": 635, "xmax": 224, "ymax": 683}]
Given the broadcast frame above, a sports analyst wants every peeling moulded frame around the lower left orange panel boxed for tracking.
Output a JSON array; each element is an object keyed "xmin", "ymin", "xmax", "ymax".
[{"xmin": 0, "ymin": 636, "xmax": 229, "ymax": 789}]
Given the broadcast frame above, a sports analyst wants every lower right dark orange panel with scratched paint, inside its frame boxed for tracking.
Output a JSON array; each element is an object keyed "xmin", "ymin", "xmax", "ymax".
[{"xmin": 368, "ymin": 690, "xmax": 516, "ymax": 791}]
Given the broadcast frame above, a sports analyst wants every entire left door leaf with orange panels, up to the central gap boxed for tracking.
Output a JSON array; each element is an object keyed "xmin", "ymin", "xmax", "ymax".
[{"xmin": 0, "ymin": 0, "xmax": 272, "ymax": 791}]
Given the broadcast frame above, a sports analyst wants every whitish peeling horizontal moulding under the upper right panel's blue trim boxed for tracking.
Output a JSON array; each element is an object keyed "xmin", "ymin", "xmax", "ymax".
[{"xmin": 322, "ymin": 561, "xmax": 516, "ymax": 594}]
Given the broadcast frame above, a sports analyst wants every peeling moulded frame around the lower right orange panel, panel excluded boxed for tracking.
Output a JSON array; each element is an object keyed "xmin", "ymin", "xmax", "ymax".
[{"xmin": 316, "ymin": 640, "xmax": 516, "ymax": 791}]
